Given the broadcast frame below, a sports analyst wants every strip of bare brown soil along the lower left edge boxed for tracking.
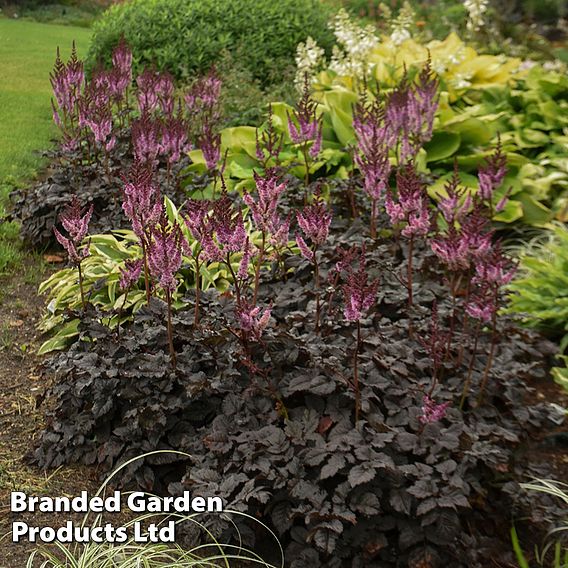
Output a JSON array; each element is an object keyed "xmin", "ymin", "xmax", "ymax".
[{"xmin": 0, "ymin": 258, "xmax": 104, "ymax": 568}]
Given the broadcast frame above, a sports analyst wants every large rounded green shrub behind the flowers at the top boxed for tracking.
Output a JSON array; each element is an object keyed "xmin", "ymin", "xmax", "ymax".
[{"xmin": 88, "ymin": 0, "xmax": 333, "ymax": 84}]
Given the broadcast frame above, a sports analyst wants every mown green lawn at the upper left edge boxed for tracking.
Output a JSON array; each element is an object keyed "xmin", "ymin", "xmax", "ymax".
[{"xmin": 0, "ymin": 18, "xmax": 90, "ymax": 274}]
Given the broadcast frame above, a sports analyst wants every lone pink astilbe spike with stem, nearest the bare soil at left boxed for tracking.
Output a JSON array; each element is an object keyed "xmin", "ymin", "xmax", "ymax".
[{"xmin": 53, "ymin": 196, "xmax": 94, "ymax": 309}]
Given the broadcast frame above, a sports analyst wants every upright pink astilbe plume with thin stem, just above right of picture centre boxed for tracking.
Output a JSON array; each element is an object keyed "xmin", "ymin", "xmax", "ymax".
[{"xmin": 296, "ymin": 188, "xmax": 332, "ymax": 333}]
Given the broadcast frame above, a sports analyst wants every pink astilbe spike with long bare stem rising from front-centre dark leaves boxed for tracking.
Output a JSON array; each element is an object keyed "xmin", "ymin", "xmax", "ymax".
[{"xmin": 343, "ymin": 246, "xmax": 379, "ymax": 423}]
